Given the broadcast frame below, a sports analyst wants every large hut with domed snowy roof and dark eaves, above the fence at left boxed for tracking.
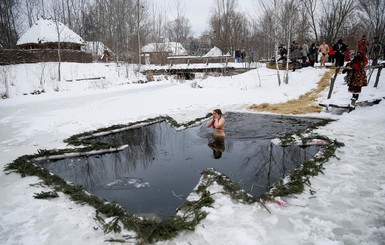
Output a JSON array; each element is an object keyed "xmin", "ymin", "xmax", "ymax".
[{"xmin": 16, "ymin": 19, "xmax": 84, "ymax": 50}]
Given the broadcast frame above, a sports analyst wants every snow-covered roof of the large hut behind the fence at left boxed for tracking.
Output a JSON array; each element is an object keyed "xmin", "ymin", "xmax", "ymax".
[{"xmin": 16, "ymin": 19, "xmax": 84, "ymax": 45}]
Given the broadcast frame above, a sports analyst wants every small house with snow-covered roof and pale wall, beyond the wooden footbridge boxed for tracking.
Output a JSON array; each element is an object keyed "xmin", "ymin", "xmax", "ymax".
[{"xmin": 141, "ymin": 42, "xmax": 187, "ymax": 65}]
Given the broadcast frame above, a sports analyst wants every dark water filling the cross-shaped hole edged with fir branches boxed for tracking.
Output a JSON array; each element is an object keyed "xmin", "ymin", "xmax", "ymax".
[{"xmin": 39, "ymin": 113, "xmax": 319, "ymax": 217}]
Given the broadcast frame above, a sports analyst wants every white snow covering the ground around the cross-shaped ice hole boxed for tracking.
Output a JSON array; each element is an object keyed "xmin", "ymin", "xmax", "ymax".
[{"xmin": 0, "ymin": 60, "xmax": 385, "ymax": 245}]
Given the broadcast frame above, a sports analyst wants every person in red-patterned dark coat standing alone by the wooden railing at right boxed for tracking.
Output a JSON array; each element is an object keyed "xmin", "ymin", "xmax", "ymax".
[{"xmin": 343, "ymin": 51, "xmax": 368, "ymax": 107}]
